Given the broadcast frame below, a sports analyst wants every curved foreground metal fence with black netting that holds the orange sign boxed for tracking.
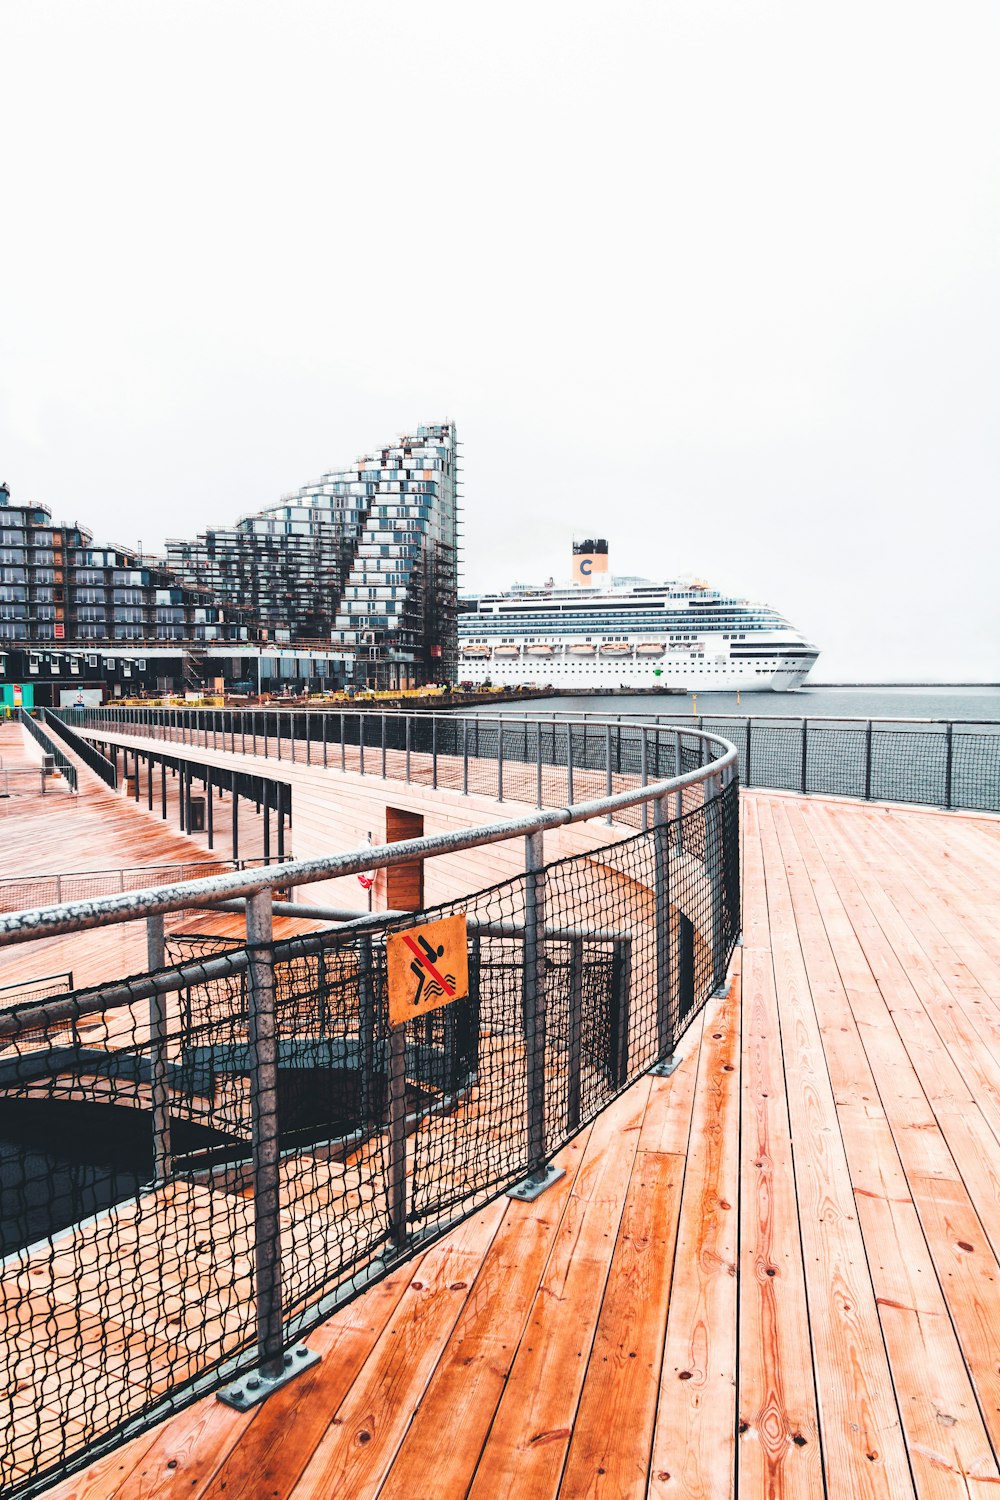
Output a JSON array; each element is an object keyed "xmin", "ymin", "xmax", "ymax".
[{"xmin": 0, "ymin": 723, "xmax": 739, "ymax": 1494}]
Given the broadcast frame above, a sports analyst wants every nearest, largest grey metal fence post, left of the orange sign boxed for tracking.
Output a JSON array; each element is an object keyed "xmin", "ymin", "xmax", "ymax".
[{"xmin": 246, "ymin": 891, "xmax": 283, "ymax": 1380}]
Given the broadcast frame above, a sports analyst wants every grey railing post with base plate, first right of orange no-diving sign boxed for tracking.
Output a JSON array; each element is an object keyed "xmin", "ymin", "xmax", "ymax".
[{"xmin": 508, "ymin": 833, "xmax": 562, "ymax": 1200}]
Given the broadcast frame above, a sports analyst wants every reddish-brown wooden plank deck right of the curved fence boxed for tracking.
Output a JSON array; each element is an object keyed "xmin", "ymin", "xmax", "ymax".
[{"xmin": 41, "ymin": 792, "xmax": 1000, "ymax": 1500}]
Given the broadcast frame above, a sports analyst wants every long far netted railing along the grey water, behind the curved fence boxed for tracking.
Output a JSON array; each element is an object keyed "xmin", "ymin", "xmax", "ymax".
[{"xmin": 48, "ymin": 707, "xmax": 1000, "ymax": 813}]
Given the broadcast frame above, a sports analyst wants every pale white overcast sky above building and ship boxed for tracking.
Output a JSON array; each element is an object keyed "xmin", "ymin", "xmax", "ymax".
[{"xmin": 0, "ymin": 0, "xmax": 1000, "ymax": 681}]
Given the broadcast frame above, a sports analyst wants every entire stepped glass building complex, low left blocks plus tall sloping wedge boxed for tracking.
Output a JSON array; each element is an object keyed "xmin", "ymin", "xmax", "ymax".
[{"xmin": 0, "ymin": 423, "xmax": 459, "ymax": 704}]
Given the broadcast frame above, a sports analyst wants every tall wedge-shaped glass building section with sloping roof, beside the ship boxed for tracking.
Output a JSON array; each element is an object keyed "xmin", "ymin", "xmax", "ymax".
[{"xmin": 166, "ymin": 423, "xmax": 459, "ymax": 689}]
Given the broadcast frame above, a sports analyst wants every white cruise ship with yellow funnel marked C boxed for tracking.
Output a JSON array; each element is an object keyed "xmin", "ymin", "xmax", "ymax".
[{"xmin": 459, "ymin": 537, "xmax": 819, "ymax": 693}]
